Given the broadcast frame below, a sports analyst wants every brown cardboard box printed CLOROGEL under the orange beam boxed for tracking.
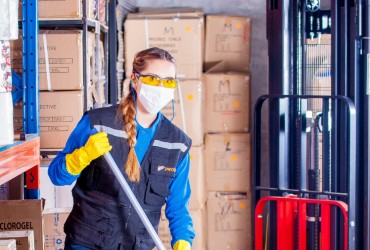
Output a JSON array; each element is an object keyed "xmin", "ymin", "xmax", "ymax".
[{"xmin": 0, "ymin": 200, "xmax": 44, "ymax": 250}]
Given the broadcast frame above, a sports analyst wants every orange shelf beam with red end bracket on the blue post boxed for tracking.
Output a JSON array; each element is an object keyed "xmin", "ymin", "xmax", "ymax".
[{"xmin": 0, "ymin": 135, "xmax": 40, "ymax": 189}]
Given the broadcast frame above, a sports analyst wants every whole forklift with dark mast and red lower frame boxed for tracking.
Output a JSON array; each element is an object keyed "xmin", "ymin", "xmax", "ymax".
[{"xmin": 252, "ymin": 0, "xmax": 370, "ymax": 250}]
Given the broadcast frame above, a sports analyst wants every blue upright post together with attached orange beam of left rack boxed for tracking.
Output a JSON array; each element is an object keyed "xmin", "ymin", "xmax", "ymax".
[{"xmin": 0, "ymin": 0, "xmax": 40, "ymax": 199}]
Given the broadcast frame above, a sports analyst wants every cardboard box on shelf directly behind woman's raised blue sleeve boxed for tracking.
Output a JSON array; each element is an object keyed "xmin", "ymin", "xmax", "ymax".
[{"xmin": 40, "ymin": 91, "xmax": 83, "ymax": 149}]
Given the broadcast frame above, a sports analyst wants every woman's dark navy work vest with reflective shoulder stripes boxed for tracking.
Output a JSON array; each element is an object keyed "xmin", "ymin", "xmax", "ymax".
[{"xmin": 60, "ymin": 106, "xmax": 191, "ymax": 250}]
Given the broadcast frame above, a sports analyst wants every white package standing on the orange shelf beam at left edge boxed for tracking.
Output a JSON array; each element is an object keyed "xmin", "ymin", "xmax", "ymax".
[{"xmin": 0, "ymin": 92, "xmax": 14, "ymax": 145}]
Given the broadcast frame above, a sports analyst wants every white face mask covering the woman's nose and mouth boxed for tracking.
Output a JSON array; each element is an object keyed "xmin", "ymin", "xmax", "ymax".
[{"xmin": 138, "ymin": 84, "xmax": 175, "ymax": 114}]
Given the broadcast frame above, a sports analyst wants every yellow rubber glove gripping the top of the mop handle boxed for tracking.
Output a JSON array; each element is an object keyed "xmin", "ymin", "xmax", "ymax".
[{"xmin": 66, "ymin": 132, "xmax": 112, "ymax": 175}]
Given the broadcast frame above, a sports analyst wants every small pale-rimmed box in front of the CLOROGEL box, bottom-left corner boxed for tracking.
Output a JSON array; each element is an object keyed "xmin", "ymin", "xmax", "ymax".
[{"xmin": 0, "ymin": 230, "xmax": 35, "ymax": 250}]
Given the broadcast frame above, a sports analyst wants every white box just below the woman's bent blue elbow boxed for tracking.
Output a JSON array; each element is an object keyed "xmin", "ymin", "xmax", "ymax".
[{"xmin": 40, "ymin": 158, "xmax": 75, "ymax": 210}]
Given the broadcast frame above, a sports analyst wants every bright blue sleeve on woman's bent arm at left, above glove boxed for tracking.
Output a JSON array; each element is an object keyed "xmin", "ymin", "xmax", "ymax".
[{"xmin": 48, "ymin": 114, "xmax": 91, "ymax": 186}]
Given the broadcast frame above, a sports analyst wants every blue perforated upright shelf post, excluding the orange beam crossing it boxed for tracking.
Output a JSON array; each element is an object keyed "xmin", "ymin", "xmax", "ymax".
[{"xmin": 22, "ymin": 0, "xmax": 40, "ymax": 199}]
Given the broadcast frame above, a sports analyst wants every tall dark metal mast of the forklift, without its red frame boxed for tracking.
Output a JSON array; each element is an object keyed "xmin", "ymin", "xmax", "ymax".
[{"xmin": 254, "ymin": 0, "xmax": 370, "ymax": 250}]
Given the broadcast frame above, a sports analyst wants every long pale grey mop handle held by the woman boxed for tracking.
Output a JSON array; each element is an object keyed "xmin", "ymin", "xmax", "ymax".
[{"xmin": 104, "ymin": 152, "xmax": 166, "ymax": 250}]
